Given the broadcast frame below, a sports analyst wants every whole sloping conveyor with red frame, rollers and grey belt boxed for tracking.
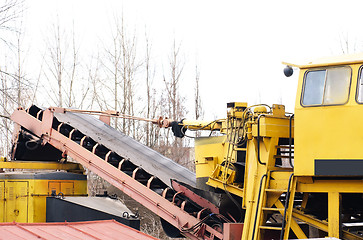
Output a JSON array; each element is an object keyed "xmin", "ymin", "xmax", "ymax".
[{"xmin": 12, "ymin": 106, "xmax": 226, "ymax": 239}]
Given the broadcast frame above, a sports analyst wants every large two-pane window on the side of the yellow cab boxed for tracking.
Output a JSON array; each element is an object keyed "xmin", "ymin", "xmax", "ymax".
[{"xmin": 301, "ymin": 67, "xmax": 351, "ymax": 106}]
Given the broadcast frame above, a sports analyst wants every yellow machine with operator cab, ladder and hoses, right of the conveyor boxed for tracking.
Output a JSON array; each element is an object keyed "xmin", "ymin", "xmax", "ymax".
[{"xmin": 172, "ymin": 55, "xmax": 363, "ymax": 240}]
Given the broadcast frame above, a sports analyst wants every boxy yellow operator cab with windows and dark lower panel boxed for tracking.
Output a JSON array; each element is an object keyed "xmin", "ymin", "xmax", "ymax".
[{"xmin": 288, "ymin": 54, "xmax": 363, "ymax": 176}]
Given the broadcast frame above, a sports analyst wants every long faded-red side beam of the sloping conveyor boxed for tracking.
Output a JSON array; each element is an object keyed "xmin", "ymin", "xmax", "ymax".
[{"xmin": 11, "ymin": 108, "xmax": 223, "ymax": 239}]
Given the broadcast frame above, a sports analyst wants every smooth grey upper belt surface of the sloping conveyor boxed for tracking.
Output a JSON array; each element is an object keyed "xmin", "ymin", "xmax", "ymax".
[{"xmin": 54, "ymin": 112, "xmax": 196, "ymax": 187}]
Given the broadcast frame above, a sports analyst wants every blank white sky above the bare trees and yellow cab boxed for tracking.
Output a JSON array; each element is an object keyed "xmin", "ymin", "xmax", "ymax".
[{"xmin": 25, "ymin": 0, "xmax": 363, "ymax": 119}]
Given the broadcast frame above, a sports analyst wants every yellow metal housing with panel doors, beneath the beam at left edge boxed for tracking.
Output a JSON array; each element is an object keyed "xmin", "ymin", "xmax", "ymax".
[{"xmin": 0, "ymin": 173, "xmax": 87, "ymax": 222}]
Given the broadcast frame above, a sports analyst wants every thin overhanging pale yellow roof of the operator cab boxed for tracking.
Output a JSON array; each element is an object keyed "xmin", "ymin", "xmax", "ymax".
[{"xmin": 282, "ymin": 53, "xmax": 363, "ymax": 69}]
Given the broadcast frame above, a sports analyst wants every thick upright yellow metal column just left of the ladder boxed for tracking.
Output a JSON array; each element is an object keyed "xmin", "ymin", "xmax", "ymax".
[{"xmin": 242, "ymin": 131, "xmax": 288, "ymax": 240}]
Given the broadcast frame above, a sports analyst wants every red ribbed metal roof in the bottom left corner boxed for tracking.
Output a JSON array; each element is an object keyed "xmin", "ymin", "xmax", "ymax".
[{"xmin": 0, "ymin": 220, "xmax": 157, "ymax": 240}]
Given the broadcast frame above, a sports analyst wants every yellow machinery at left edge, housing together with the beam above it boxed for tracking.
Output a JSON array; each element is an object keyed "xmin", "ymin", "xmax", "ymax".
[{"xmin": 0, "ymin": 158, "xmax": 87, "ymax": 223}]
